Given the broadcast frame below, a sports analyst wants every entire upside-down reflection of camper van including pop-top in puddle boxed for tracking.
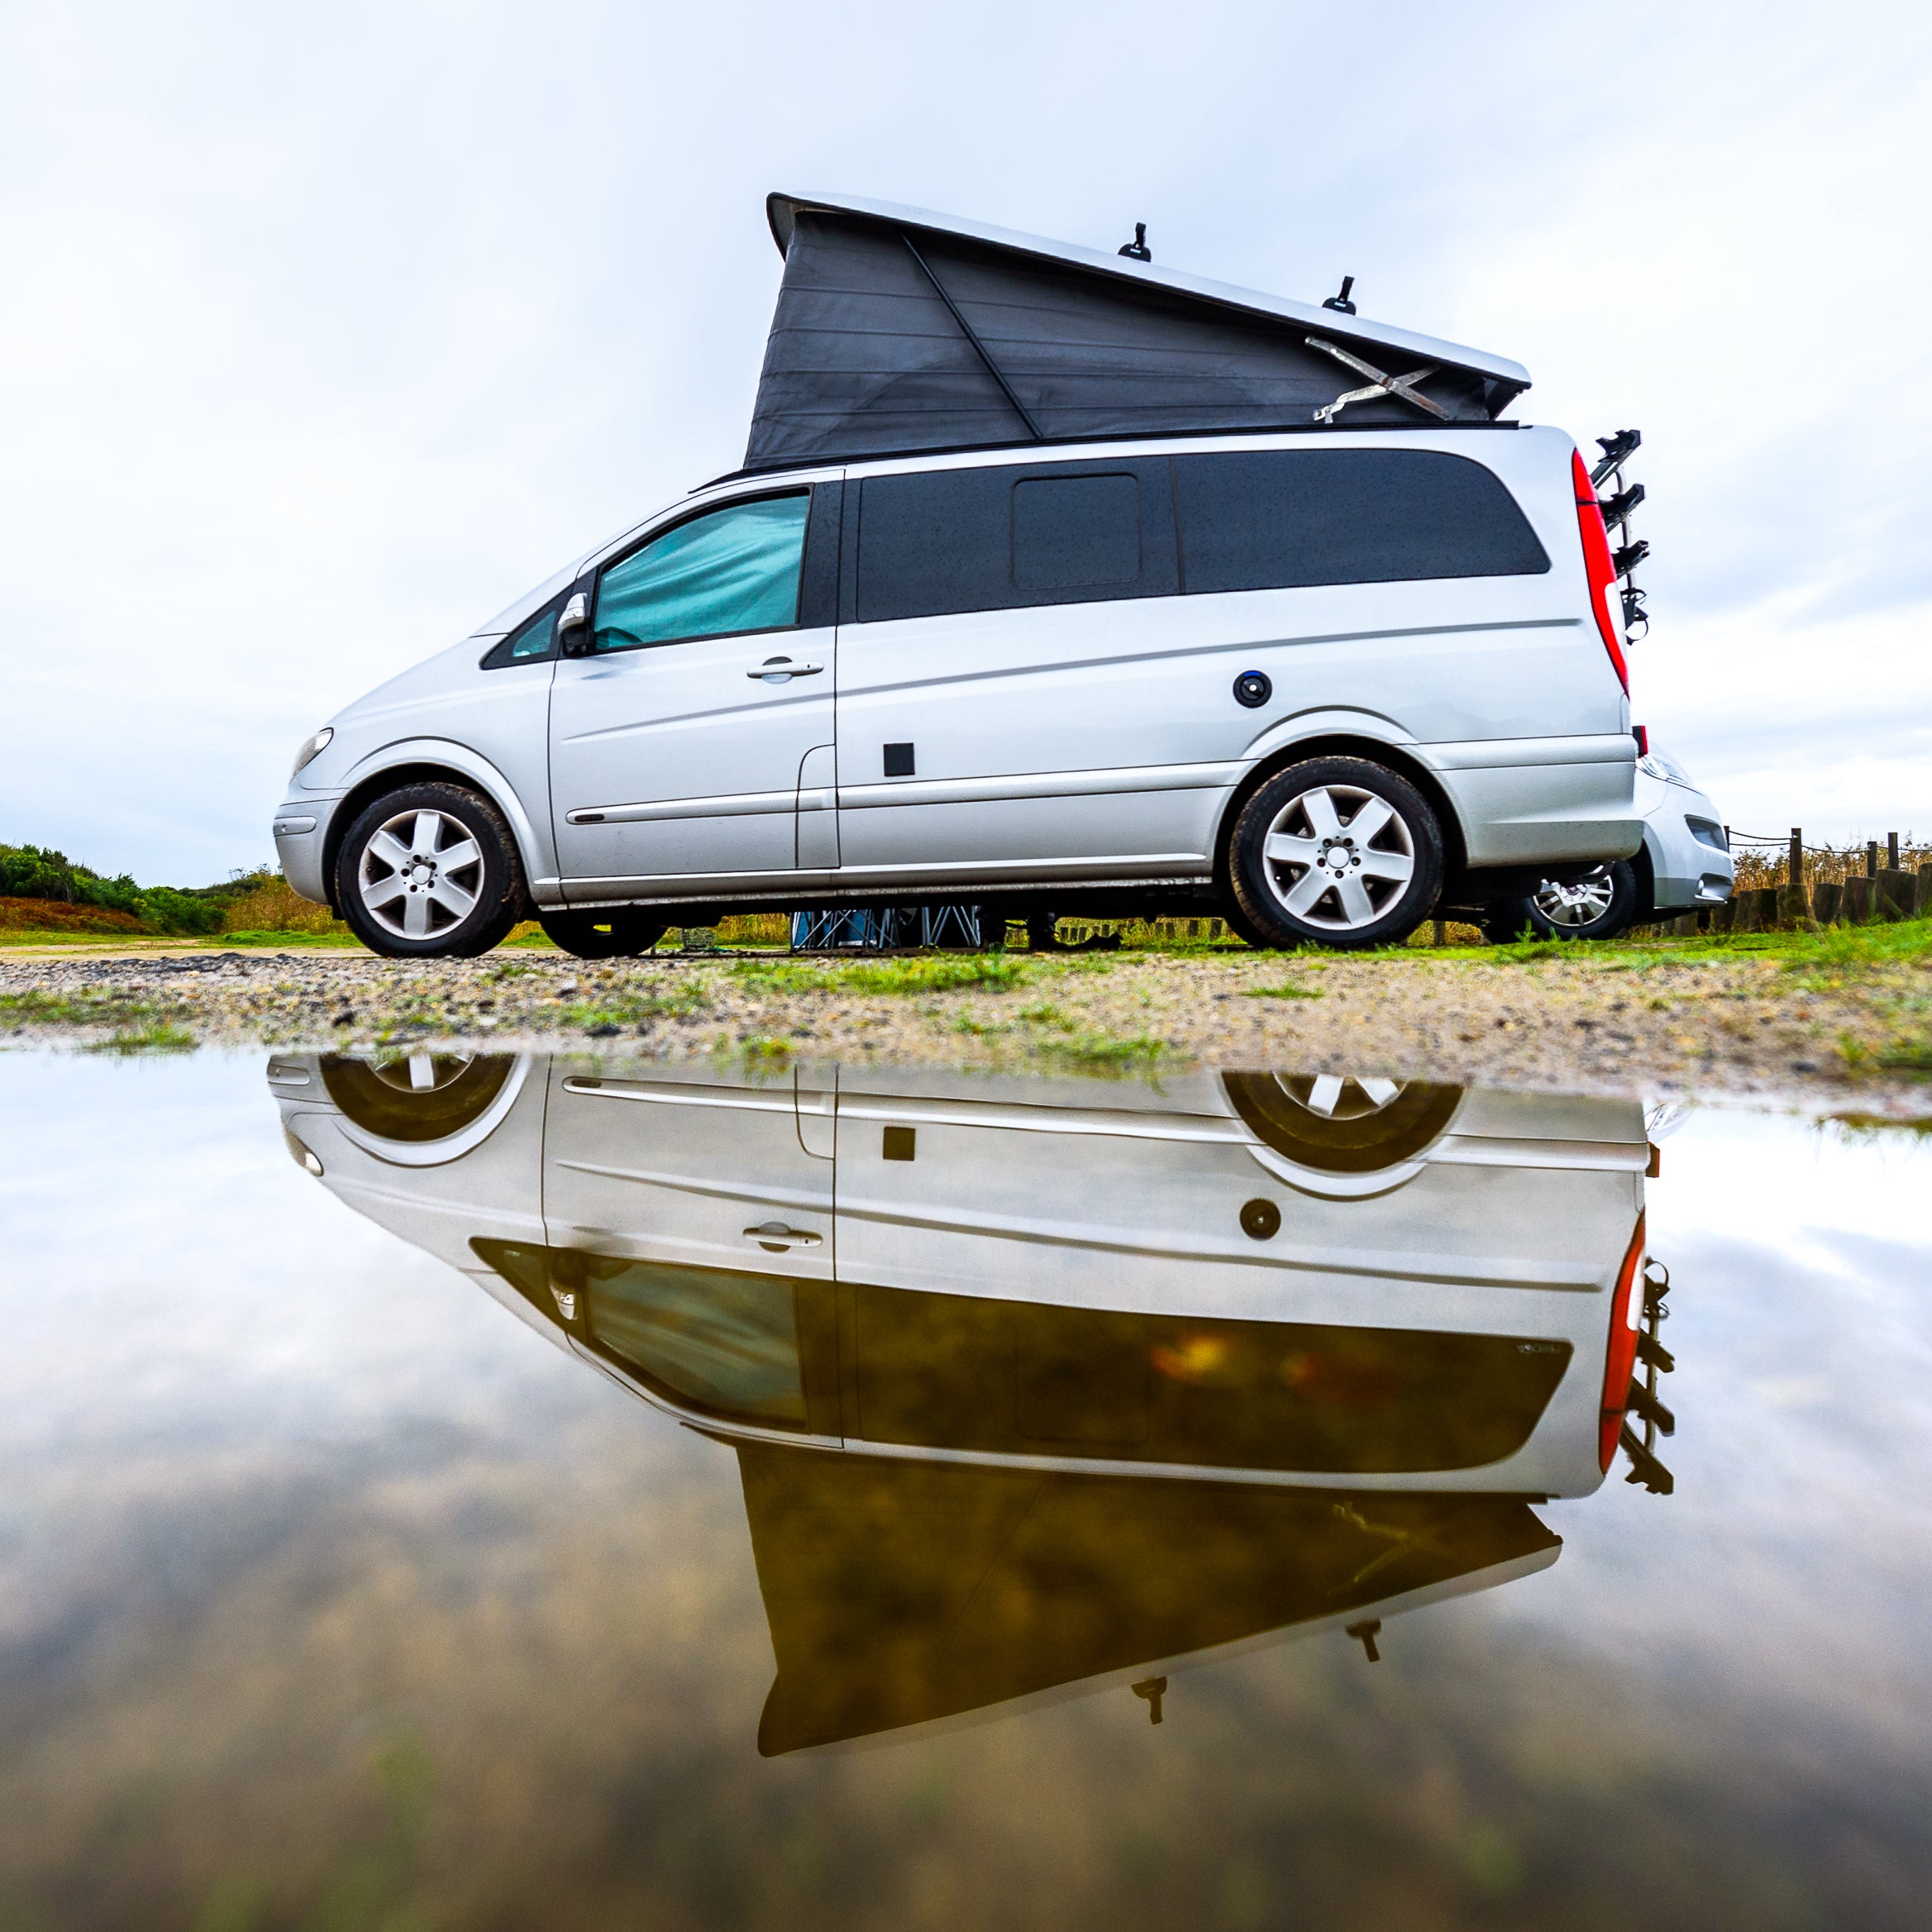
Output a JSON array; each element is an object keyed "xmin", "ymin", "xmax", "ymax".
[{"xmin": 270, "ymin": 1053, "xmax": 1648, "ymax": 1750}]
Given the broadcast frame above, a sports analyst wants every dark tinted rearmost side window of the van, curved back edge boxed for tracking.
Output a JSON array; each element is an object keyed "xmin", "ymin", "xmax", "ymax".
[{"xmin": 1175, "ymin": 451, "xmax": 1549, "ymax": 595}]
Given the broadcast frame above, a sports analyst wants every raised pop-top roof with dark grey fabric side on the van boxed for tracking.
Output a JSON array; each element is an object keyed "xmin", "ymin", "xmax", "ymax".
[{"xmin": 746, "ymin": 195, "xmax": 1530, "ymax": 470}]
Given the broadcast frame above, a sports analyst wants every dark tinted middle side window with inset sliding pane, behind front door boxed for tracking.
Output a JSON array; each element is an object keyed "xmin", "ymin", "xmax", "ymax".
[{"xmin": 854, "ymin": 458, "xmax": 1181, "ymax": 624}]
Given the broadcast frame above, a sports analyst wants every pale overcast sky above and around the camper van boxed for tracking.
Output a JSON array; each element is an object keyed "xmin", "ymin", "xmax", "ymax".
[{"xmin": 0, "ymin": 0, "xmax": 1932, "ymax": 883}]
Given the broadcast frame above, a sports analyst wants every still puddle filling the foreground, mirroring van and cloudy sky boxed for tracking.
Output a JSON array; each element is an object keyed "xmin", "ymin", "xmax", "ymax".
[{"xmin": 0, "ymin": 1053, "xmax": 1932, "ymax": 1928}]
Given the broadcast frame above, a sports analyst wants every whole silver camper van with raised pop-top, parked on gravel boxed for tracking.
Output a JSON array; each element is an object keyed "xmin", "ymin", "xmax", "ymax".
[{"xmin": 274, "ymin": 195, "xmax": 1642, "ymax": 956}]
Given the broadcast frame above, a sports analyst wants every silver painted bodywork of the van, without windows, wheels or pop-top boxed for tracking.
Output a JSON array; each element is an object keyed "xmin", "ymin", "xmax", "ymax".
[{"xmin": 276, "ymin": 427, "xmax": 1642, "ymax": 927}]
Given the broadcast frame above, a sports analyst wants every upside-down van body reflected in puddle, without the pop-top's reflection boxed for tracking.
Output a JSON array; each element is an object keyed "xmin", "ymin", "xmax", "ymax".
[{"xmin": 273, "ymin": 1055, "xmax": 1648, "ymax": 1496}]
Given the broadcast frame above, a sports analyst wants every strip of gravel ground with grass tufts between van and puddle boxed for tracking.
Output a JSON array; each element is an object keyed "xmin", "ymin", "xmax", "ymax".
[{"xmin": 0, "ymin": 948, "xmax": 1932, "ymax": 1117}]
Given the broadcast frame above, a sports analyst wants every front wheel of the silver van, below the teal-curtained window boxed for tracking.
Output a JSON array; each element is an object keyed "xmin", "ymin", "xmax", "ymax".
[{"xmin": 336, "ymin": 780, "xmax": 523, "ymax": 958}]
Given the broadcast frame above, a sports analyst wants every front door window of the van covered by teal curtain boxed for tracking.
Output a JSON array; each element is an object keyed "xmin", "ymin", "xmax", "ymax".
[{"xmin": 593, "ymin": 493, "xmax": 812, "ymax": 651}]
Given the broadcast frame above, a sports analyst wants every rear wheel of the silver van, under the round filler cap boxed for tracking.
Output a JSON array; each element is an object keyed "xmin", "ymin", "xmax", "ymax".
[{"xmin": 1228, "ymin": 757, "xmax": 1443, "ymax": 951}]
